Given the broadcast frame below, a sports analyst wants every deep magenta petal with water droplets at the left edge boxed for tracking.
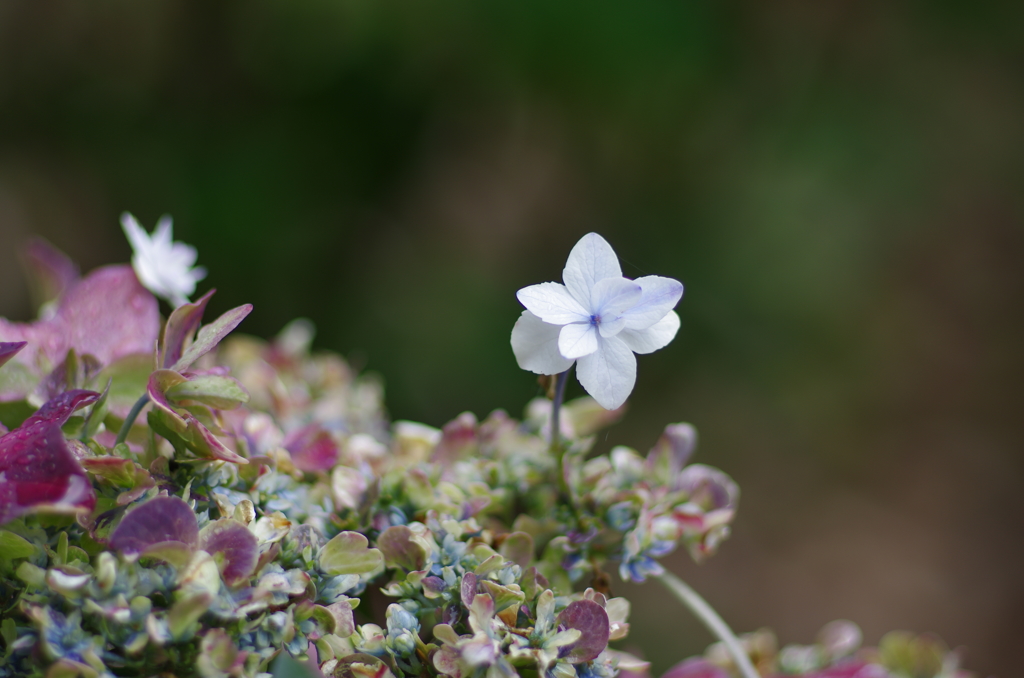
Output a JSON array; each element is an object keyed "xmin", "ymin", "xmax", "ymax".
[{"xmin": 0, "ymin": 390, "xmax": 99, "ymax": 524}]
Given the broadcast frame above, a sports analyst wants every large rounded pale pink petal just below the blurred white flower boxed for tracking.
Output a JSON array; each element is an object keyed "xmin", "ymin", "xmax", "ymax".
[{"xmin": 51, "ymin": 266, "xmax": 160, "ymax": 365}]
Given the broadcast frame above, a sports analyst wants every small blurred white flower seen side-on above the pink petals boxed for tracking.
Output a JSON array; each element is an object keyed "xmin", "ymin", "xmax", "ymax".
[{"xmin": 121, "ymin": 212, "xmax": 206, "ymax": 306}]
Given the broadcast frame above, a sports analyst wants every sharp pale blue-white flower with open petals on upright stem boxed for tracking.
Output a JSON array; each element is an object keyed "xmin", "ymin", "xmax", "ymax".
[{"xmin": 512, "ymin": 234, "xmax": 683, "ymax": 410}]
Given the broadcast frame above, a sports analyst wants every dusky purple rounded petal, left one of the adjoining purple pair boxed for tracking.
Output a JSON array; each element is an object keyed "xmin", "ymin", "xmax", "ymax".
[{"xmin": 110, "ymin": 497, "xmax": 199, "ymax": 554}]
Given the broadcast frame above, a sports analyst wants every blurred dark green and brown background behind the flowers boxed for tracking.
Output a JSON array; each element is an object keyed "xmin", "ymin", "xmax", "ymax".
[{"xmin": 0, "ymin": 0, "xmax": 1024, "ymax": 677}]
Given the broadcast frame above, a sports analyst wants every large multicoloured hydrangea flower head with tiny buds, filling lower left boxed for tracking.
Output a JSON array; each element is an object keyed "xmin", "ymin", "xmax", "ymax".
[{"xmin": 0, "ymin": 238, "xmax": 737, "ymax": 678}]
